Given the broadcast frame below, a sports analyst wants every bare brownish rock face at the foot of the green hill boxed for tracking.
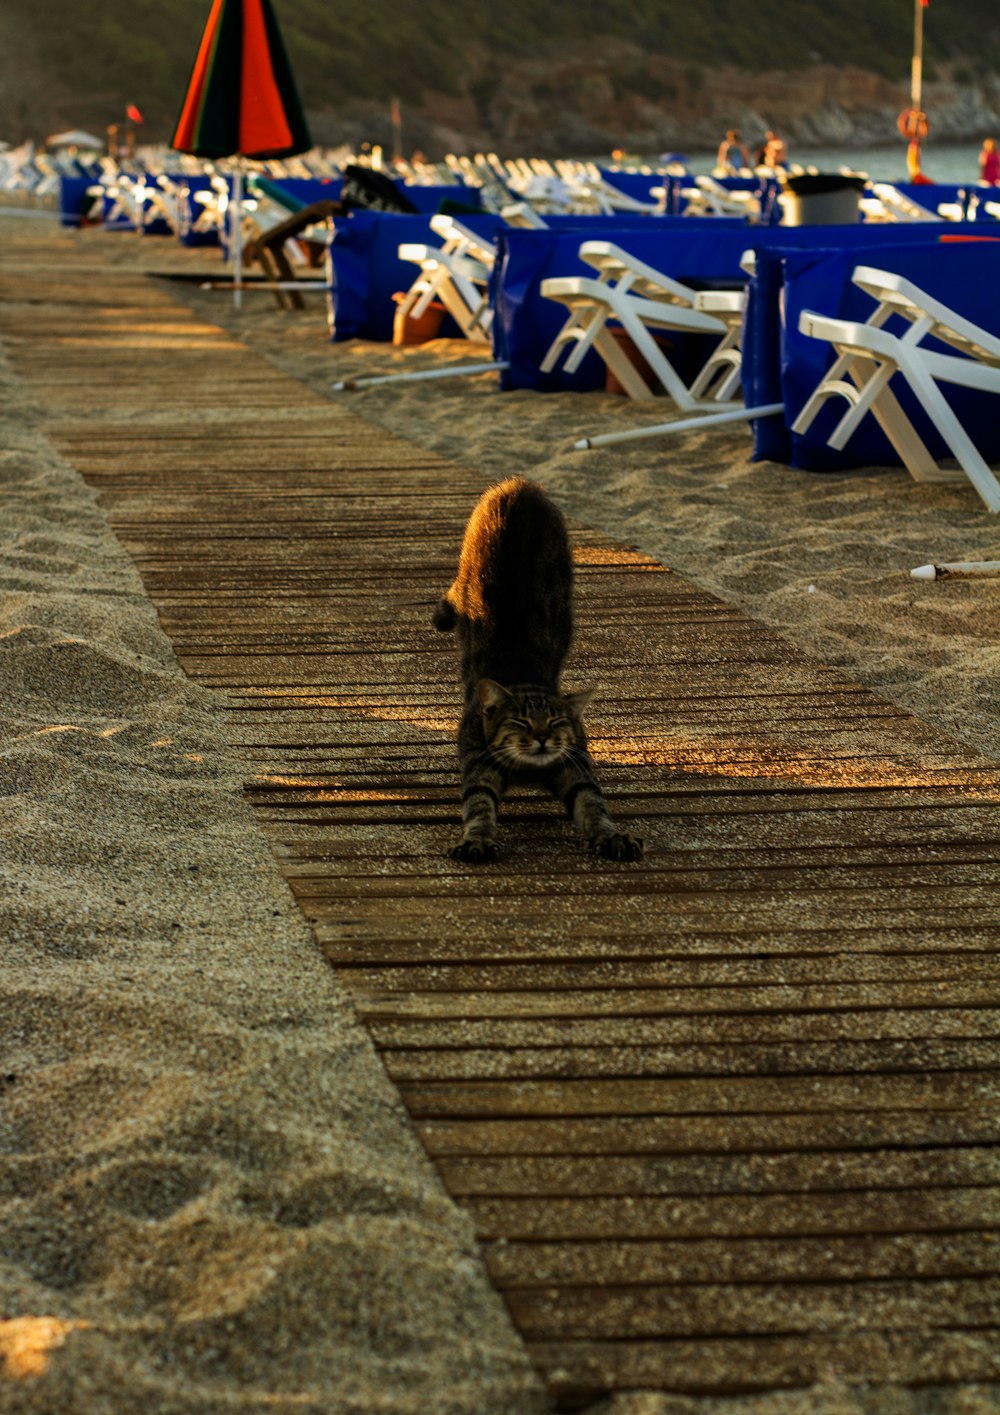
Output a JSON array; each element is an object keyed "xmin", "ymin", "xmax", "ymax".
[{"xmin": 376, "ymin": 42, "xmax": 1000, "ymax": 156}]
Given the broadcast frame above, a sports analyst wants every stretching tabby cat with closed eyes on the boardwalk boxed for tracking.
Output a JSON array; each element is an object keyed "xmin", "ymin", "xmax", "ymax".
[{"xmin": 434, "ymin": 477, "xmax": 642, "ymax": 865}]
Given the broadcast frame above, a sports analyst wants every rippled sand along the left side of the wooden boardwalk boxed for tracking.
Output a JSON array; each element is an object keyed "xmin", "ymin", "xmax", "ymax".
[{"xmin": 0, "ymin": 217, "xmax": 545, "ymax": 1415}]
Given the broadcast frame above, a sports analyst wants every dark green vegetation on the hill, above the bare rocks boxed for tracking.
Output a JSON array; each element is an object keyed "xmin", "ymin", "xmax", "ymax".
[{"xmin": 0, "ymin": 0, "xmax": 1000, "ymax": 139}]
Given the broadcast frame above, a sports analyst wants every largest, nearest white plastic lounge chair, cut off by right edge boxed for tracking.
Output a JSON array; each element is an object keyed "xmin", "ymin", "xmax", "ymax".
[{"xmin": 792, "ymin": 266, "xmax": 1000, "ymax": 511}]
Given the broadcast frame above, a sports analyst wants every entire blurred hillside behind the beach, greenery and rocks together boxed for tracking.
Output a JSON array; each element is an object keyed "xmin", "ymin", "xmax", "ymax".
[{"xmin": 0, "ymin": 0, "xmax": 1000, "ymax": 157}]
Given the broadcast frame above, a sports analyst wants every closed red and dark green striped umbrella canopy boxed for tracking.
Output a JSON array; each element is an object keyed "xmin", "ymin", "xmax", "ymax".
[{"xmin": 170, "ymin": 0, "xmax": 313, "ymax": 158}]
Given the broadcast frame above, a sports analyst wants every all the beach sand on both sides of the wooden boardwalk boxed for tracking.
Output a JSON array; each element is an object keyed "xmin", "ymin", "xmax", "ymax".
[{"xmin": 0, "ymin": 218, "xmax": 1000, "ymax": 1415}]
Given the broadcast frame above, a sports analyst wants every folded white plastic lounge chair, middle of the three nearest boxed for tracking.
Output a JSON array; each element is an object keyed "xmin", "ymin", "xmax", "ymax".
[{"xmin": 540, "ymin": 241, "xmax": 730, "ymax": 410}]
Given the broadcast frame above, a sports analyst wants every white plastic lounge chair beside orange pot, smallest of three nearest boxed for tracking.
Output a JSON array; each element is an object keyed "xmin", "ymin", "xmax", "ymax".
[{"xmin": 399, "ymin": 214, "xmax": 495, "ymax": 344}]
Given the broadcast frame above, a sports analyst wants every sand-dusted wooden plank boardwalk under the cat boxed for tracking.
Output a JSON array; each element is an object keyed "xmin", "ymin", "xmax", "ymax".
[{"xmin": 0, "ymin": 232, "xmax": 1000, "ymax": 1409}]
